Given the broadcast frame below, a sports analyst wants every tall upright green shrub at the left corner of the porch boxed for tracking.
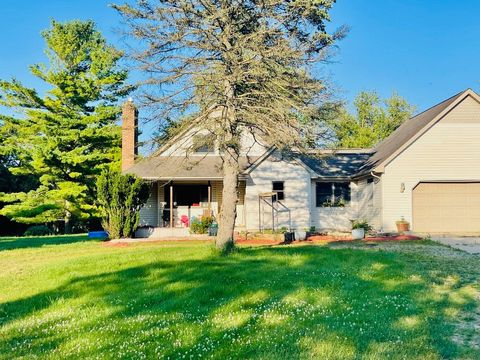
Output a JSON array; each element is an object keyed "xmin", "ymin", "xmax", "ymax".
[{"xmin": 97, "ymin": 169, "xmax": 150, "ymax": 239}]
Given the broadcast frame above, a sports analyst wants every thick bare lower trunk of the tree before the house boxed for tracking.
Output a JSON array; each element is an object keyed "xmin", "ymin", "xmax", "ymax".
[{"xmin": 215, "ymin": 151, "xmax": 239, "ymax": 252}]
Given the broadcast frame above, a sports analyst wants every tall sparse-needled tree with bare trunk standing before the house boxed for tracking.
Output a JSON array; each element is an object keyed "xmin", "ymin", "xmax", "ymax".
[{"xmin": 115, "ymin": 0, "xmax": 344, "ymax": 249}]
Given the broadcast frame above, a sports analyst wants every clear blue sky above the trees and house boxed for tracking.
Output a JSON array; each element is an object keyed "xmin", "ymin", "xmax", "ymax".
[{"xmin": 0, "ymin": 0, "xmax": 480, "ymax": 136}]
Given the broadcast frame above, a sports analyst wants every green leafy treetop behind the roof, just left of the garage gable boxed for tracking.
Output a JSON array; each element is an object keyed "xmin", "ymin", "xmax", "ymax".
[{"xmin": 327, "ymin": 91, "xmax": 414, "ymax": 148}]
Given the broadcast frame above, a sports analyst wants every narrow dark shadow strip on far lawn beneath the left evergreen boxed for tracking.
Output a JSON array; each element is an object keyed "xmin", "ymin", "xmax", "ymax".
[{"xmin": 0, "ymin": 234, "xmax": 94, "ymax": 251}]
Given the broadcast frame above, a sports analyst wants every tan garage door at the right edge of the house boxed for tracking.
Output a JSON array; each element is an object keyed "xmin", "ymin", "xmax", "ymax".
[{"xmin": 413, "ymin": 183, "xmax": 480, "ymax": 233}]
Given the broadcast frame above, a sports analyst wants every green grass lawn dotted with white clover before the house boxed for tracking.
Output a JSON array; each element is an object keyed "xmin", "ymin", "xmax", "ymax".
[{"xmin": 0, "ymin": 236, "xmax": 480, "ymax": 359}]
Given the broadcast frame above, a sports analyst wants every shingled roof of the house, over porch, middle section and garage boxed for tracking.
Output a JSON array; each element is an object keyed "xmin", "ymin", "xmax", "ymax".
[{"xmin": 127, "ymin": 91, "xmax": 465, "ymax": 180}]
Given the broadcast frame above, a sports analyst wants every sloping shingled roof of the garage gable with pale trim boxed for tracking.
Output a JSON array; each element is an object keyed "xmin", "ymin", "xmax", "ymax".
[{"xmin": 358, "ymin": 89, "xmax": 480, "ymax": 175}]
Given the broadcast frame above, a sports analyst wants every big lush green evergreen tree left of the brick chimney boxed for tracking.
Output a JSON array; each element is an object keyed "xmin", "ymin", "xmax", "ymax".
[{"xmin": 0, "ymin": 21, "xmax": 128, "ymax": 232}]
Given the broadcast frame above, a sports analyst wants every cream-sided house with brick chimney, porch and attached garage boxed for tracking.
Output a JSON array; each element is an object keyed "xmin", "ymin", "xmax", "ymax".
[{"xmin": 122, "ymin": 89, "xmax": 480, "ymax": 236}]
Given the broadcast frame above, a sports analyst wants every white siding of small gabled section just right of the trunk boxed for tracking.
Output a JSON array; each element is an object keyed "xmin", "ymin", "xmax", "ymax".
[{"xmin": 245, "ymin": 154, "xmax": 311, "ymax": 230}]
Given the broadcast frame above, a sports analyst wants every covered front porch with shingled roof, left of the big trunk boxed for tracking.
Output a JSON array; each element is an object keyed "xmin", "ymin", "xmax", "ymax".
[{"xmin": 128, "ymin": 155, "xmax": 251, "ymax": 238}]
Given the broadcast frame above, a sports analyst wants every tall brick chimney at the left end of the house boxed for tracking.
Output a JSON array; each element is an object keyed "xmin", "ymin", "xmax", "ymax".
[{"xmin": 122, "ymin": 98, "xmax": 138, "ymax": 171}]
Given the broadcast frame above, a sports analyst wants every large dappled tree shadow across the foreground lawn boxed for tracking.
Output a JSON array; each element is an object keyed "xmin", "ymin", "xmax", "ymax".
[{"xmin": 0, "ymin": 247, "xmax": 475, "ymax": 359}]
